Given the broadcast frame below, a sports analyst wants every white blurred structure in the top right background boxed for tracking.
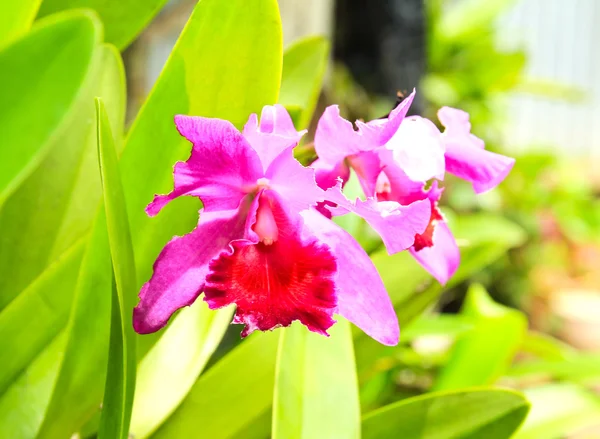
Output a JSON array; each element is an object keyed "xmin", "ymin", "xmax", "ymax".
[{"xmin": 498, "ymin": 0, "xmax": 600, "ymax": 162}]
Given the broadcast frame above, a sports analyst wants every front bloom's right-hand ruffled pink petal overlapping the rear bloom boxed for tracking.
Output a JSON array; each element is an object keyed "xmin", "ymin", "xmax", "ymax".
[{"xmin": 326, "ymin": 185, "xmax": 431, "ymax": 255}]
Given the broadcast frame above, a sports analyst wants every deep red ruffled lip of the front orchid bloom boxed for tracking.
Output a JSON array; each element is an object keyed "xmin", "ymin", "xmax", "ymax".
[{"xmin": 204, "ymin": 194, "xmax": 337, "ymax": 337}]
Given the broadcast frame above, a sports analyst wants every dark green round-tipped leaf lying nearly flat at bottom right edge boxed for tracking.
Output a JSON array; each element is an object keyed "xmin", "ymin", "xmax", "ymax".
[{"xmin": 362, "ymin": 389, "xmax": 528, "ymax": 439}]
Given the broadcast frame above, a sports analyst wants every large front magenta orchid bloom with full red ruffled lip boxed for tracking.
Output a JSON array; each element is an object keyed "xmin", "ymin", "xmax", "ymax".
[{"xmin": 133, "ymin": 105, "xmax": 431, "ymax": 345}]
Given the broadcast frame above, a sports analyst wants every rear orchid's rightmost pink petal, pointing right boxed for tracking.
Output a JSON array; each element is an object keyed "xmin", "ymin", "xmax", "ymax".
[{"xmin": 438, "ymin": 107, "xmax": 515, "ymax": 193}]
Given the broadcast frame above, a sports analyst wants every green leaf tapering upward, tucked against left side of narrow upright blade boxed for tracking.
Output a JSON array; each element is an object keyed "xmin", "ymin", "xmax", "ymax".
[{"xmin": 38, "ymin": 209, "xmax": 112, "ymax": 439}]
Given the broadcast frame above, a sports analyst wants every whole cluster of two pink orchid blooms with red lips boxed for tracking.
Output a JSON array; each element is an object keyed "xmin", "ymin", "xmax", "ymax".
[{"xmin": 133, "ymin": 92, "xmax": 514, "ymax": 345}]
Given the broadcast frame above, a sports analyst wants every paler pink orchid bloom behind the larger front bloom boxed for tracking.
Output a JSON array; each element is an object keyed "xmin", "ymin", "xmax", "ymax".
[{"xmin": 313, "ymin": 91, "xmax": 514, "ymax": 284}]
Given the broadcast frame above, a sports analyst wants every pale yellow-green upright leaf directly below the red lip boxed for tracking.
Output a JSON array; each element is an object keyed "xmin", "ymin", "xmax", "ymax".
[{"xmin": 272, "ymin": 318, "xmax": 360, "ymax": 439}]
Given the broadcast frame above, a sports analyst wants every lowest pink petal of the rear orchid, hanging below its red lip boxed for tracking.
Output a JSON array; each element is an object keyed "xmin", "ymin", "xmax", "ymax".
[{"xmin": 410, "ymin": 221, "xmax": 460, "ymax": 285}]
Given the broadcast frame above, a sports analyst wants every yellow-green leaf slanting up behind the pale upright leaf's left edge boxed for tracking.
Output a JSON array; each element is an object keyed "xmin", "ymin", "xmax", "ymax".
[{"xmin": 151, "ymin": 332, "xmax": 279, "ymax": 439}]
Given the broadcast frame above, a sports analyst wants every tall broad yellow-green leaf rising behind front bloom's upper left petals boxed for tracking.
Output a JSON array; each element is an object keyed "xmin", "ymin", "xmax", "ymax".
[{"xmin": 120, "ymin": 0, "xmax": 282, "ymax": 300}]
